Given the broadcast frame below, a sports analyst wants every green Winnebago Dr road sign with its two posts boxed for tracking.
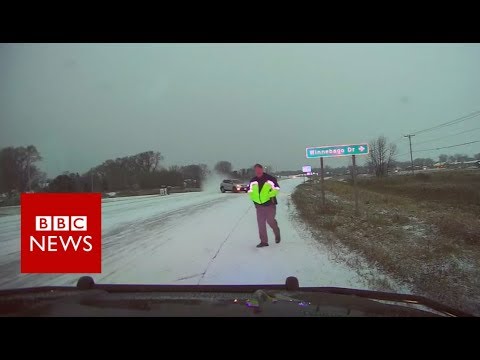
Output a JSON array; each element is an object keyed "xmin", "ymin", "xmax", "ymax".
[{"xmin": 306, "ymin": 143, "xmax": 370, "ymax": 215}]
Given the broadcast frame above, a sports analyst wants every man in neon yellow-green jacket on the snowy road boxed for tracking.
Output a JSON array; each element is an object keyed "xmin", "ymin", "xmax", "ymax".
[{"xmin": 248, "ymin": 164, "xmax": 280, "ymax": 247}]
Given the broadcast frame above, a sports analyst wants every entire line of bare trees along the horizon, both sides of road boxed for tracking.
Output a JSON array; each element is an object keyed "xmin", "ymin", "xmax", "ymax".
[{"xmin": 0, "ymin": 142, "xmax": 480, "ymax": 194}]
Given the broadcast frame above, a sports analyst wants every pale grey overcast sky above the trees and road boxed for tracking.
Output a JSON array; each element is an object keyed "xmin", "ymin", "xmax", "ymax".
[{"xmin": 0, "ymin": 44, "xmax": 480, "ymax": 176}]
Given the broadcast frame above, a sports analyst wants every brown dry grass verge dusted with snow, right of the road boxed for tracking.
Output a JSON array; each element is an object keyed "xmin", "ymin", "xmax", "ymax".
[{"xmin": 292, "ymin": 174, "xmax": 480, "ymax": 315}]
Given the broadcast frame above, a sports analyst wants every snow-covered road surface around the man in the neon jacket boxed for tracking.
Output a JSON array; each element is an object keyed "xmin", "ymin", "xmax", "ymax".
[{"xmin": 0, "ymin": 179, "xmax": 366, "ymax": 289}]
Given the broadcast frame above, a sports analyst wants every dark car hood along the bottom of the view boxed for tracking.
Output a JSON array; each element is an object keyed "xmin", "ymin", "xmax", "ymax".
[{"xmin": 0, "ymin": 277, "xmax": 470, "ymax": 317}]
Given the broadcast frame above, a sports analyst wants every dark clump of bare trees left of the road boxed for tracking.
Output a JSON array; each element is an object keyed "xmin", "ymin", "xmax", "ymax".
[{"xmin": 0, "ymin": 145, "xmax": 214, "ymax": 193}]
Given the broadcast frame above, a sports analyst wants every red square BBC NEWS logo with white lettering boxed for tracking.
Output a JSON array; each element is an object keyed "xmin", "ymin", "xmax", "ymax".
[{"xmin": 20, "ymin": 193, "xmax": 102, "ymax": 273}]
